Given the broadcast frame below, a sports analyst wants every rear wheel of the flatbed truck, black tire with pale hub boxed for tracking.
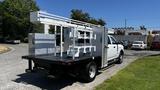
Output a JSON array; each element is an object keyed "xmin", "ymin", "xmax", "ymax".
[{"xmin": 81, "ymin": 62, "xmax": 97, "ymax": 82}]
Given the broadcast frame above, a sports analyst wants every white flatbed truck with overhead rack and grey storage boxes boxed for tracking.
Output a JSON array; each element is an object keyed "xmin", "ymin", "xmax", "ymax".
[{"xmin": 22, "ymin": 11, "xmax": 124, "ymax": 82}]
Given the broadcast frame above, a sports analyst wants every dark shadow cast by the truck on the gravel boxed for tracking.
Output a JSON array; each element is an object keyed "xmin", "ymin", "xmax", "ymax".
[{"xmin": 13, "ymin": 72, "xmax": 77, "ymax": 90}]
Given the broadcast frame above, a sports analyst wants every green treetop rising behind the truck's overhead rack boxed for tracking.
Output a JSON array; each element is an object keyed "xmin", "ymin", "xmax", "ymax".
[{"xmin": 71, "ymin": 9, "xmax": 106, "ymax": 26}]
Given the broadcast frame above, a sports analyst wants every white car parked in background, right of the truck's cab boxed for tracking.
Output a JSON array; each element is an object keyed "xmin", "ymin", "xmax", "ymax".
[{"xmin": 131, "ymin": 41, "xmax": 147, "ymax": 49}]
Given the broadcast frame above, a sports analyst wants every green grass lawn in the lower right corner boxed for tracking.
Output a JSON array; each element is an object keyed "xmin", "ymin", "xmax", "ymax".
[{"xmin": 95, "ymin": 56, "xmax": 160, "ymax": 90}]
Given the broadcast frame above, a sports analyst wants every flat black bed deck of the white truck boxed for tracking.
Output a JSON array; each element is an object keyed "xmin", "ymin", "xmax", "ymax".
[{"xmin": 22, "ymin": 54, "xmax": 100, "ymax": 65}]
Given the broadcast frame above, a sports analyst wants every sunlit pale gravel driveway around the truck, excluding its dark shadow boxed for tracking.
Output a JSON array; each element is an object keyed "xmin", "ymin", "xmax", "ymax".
[{"xmin": 0, "ymin": 44, "xmax": 160, "ymax": 90}]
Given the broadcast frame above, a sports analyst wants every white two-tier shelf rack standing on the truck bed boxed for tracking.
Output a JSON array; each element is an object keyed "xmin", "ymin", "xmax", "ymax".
[{"xmin": 67, "ymin": 29, "xmax": 96, "ymax": 57}]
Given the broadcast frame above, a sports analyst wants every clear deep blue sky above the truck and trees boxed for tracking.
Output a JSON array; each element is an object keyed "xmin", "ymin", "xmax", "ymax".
[{"xmin": 36, "ymin": 0, "xmax": 160, "ymax": 28}]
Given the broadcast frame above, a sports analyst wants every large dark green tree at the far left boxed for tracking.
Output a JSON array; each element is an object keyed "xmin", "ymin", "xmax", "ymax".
[{"xmin": 0, "ymin": 0, "xmax": 39, "ymax": 40}]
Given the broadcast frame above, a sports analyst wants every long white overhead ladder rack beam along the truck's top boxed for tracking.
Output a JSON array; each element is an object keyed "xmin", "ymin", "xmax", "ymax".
[{"xmin": 30, "ymin": 11, "xmax": 100, "ymax": 29}]
